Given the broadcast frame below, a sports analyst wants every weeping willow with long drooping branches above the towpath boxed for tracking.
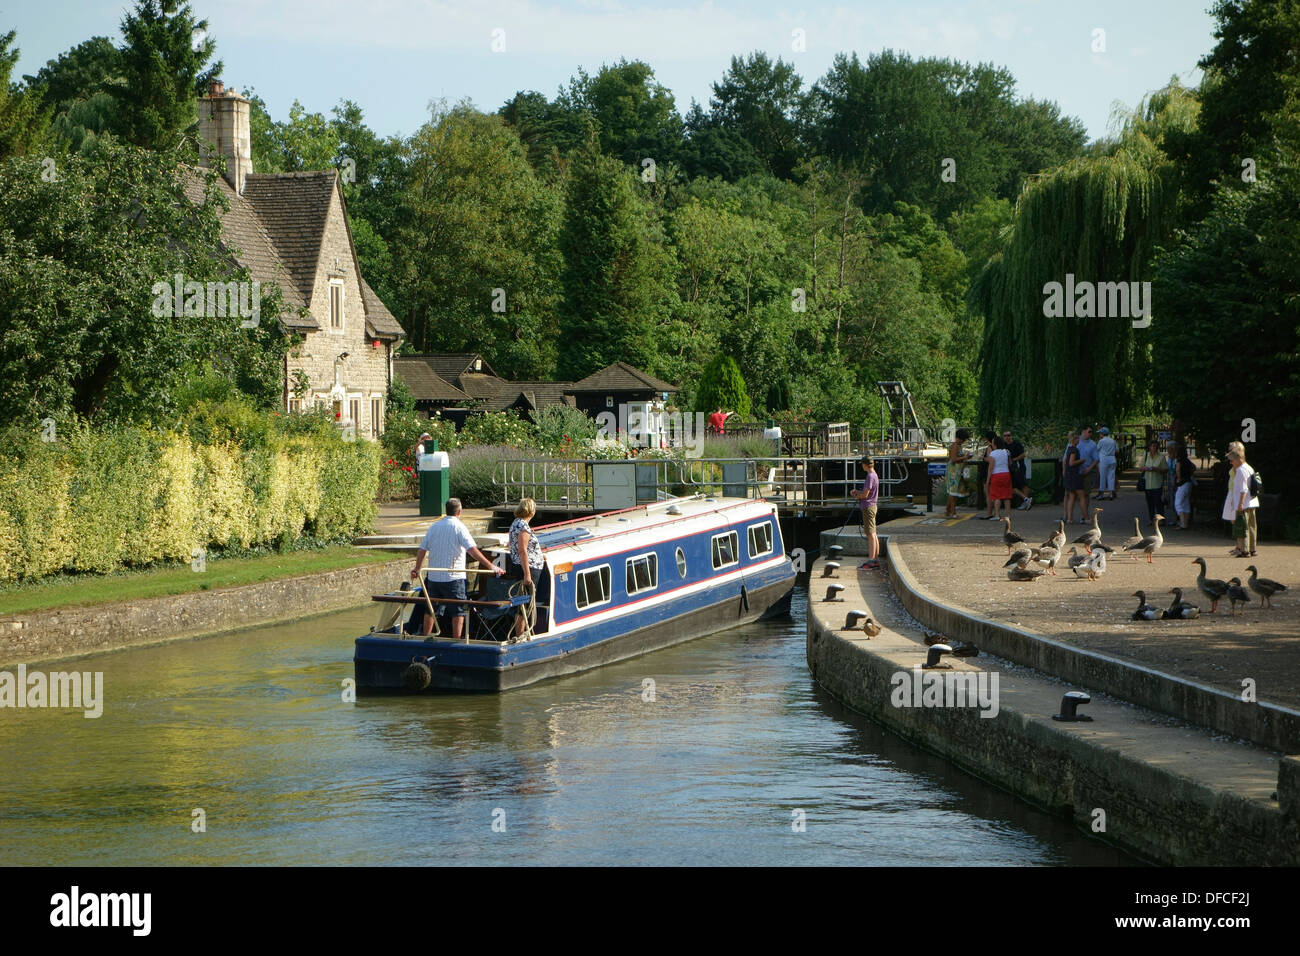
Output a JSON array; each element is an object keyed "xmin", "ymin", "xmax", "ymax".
[{"xmin": 970, "ymin": 81, "xmax": 1196, "ymax": 423}]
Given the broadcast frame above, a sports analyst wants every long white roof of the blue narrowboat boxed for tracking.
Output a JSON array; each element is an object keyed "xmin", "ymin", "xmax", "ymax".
[{"xmin": 534, "ymin": 496, "xmax": 776, "ymax": 564}]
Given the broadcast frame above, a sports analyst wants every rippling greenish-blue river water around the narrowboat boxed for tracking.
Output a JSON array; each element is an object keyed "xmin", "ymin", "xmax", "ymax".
[{"xmin": 0, "ymin": 589, "xmax": 1128, "ymax": 866}]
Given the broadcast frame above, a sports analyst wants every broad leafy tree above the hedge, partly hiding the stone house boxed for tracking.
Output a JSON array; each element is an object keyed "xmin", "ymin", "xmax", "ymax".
[{"xmin": 0, "ymin": 138, "xmax": 289, "ymax": 420}]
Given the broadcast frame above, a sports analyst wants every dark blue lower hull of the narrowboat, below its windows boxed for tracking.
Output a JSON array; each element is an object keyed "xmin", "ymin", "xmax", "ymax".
[{"xmin": 352, "ymin": 562, "xmax": 794, "ymax": 693}]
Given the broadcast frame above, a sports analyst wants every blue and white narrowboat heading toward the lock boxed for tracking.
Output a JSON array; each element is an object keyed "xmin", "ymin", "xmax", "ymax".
[{"xmin": 354, "ymin": 496, "xmax": 794, "ymax": 693}]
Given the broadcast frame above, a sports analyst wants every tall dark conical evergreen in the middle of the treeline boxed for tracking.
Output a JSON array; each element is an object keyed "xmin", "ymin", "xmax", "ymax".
[{"xmin": 558, "ymin": 138, "xmax": 676, "ymax": 381}]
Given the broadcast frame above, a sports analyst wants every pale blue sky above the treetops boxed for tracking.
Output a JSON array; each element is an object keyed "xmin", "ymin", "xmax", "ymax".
[{"xmin": 0, "ymin": 0, "xmax": 1214, "ymax": 138}]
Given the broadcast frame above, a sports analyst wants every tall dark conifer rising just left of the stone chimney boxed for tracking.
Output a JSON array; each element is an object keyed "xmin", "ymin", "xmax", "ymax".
[{"xmin": 111, "ymin": 0, "xmax": 222, "ymax": 148}]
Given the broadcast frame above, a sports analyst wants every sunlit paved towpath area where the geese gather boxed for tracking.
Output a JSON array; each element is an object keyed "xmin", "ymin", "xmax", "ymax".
[{"xmin": 873, "ymin": 480, "xmax": 1300, "ymax": 708}]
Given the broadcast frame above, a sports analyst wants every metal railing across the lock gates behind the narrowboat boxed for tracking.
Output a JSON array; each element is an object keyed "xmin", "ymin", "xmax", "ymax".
[{"xmin": 493, "ymin": 447, "xmax": 923, "ymax": 507}]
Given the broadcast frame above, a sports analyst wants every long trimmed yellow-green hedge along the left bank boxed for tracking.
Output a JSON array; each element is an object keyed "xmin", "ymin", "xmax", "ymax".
[{"xmin": 0, "ymin": 425, "xmax": 381, "ymax": 581}]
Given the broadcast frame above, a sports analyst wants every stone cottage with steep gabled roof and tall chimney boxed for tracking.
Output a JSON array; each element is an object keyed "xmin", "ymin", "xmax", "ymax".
[{"xmin": 191, "ymin": 82, "xmax": 404, "ymax": 438}]
